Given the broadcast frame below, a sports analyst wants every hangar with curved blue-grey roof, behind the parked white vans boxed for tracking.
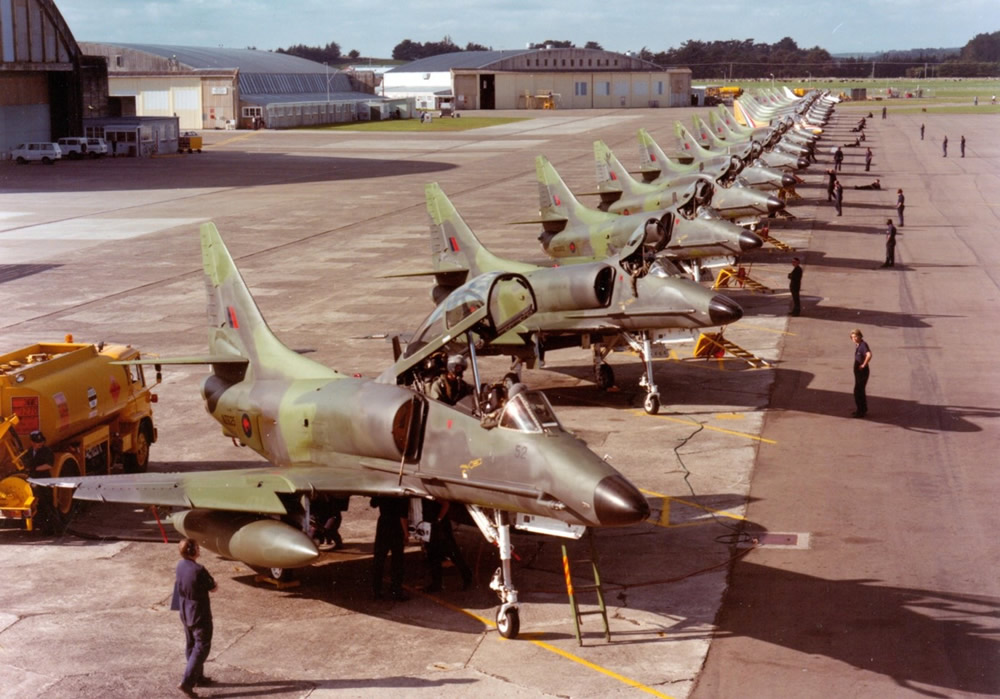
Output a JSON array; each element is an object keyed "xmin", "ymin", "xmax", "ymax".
[{"xmin": 80, "ymin": 42, "xmax": 396, "ymax": 130}]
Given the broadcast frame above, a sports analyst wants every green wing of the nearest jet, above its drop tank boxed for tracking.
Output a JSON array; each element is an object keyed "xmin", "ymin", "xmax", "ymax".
[{"xmin": 30, "ymin": 456, "xmax": 422, "ymax": 515}]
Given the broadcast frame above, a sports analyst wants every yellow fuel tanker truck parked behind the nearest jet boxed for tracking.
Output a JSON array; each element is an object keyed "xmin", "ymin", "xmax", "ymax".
[{"xmin": 0, "ymin": 337, "xmax": 159, "ymax": 532}]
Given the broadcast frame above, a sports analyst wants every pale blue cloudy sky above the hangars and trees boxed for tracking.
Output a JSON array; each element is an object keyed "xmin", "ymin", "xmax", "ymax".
[{"xmin": 55, "ymin": 0, "xmax": 1000, "ymax": 58}]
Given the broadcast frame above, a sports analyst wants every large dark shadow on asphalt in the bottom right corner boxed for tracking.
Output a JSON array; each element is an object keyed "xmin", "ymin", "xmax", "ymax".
[{"xmin": 716, "ymin": 559, "xmax": 1000, "ymax": 697}]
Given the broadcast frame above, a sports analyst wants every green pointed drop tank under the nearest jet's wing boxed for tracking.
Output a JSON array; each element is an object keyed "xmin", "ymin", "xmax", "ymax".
[{"xmin": 171, "ymin": 510, "xmax": 319, "ymax": 568}]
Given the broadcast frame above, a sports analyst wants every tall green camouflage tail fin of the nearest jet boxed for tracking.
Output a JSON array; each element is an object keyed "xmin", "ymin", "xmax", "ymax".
[{"xmin": 201, "ymin": 223, "xmax": 337, "ymax": 378}]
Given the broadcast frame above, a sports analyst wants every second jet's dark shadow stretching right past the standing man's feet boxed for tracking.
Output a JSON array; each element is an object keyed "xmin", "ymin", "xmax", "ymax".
[{"xmin": 539, "ymin": 360, "xmax": 1000, "ymax": 432}]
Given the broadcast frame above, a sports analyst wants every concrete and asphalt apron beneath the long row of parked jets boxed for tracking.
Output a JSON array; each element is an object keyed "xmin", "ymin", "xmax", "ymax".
[{"xmin": 0, "ymin": 101, "xmax": 1000, "ymax": 697}]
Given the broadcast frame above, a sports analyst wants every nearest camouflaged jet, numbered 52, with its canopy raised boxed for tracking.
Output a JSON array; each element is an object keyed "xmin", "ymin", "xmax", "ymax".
[{"xmin": 33, "ymin": 223, "xmax": 649, "ymax": 638}]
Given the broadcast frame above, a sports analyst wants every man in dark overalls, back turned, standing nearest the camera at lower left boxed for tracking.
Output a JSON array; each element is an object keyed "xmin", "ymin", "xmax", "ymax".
[{"xmin": 170, "ymin": 538, "xmax": 216, "ymax": 697}]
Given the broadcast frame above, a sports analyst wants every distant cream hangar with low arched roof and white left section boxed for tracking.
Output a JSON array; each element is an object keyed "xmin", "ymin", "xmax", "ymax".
[{"xmin": 382, "ymin": 48, "xmax": 691, "ymax": 109}]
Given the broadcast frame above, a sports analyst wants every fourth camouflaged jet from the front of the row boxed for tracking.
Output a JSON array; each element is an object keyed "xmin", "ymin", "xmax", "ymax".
[{"xmin": 594, "ymin": 141, "xmax": 785, "ymax": 232}]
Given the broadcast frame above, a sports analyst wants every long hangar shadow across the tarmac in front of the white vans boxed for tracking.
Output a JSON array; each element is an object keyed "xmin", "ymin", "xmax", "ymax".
[{"xmin": 0, "ymin": 151, "xmax": 456, "ymax": 193}]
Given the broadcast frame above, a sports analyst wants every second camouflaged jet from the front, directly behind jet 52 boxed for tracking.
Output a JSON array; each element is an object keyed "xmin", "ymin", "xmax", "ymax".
[{"xmin": 425, "ymin": 183, "xmax": 743, "ymax": 415}]
